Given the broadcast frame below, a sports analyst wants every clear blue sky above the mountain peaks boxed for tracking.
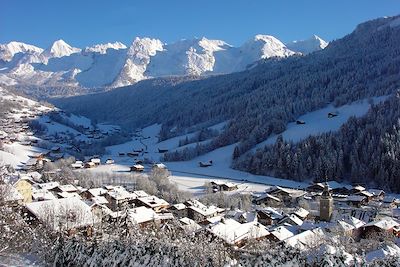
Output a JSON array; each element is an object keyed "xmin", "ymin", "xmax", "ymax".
[{"xmin": 0, "ymin": 0, "xmax": 400, "ymax": 48}]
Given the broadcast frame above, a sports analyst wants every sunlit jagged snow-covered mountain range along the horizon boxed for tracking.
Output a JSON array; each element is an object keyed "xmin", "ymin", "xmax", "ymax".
[{"xmin": 0, "ymin": 35, "xmax": 327, "ymax": 88}]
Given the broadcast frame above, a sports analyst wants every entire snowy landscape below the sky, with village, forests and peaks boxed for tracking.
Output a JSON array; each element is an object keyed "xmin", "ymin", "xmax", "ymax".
[{"xmin": 0, "ymin": 11, "xmax": 400, "ymax": 267}]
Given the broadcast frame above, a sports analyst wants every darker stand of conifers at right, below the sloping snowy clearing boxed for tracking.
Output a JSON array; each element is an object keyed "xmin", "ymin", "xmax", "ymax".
[{"xmin": 233, "ymin": 93, "xmax": 400, "ymax": 192}]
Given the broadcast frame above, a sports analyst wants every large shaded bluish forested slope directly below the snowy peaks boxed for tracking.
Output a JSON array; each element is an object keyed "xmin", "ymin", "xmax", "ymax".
[{"xmin": 54, "ymin": 17, "xmax": 400, "ymax": 158}]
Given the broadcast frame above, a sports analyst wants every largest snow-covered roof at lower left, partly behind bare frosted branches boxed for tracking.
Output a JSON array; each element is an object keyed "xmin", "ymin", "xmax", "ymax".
[{"xmin": 26, "ymin": 197, "xmax": 100, "ymax": 230}]
